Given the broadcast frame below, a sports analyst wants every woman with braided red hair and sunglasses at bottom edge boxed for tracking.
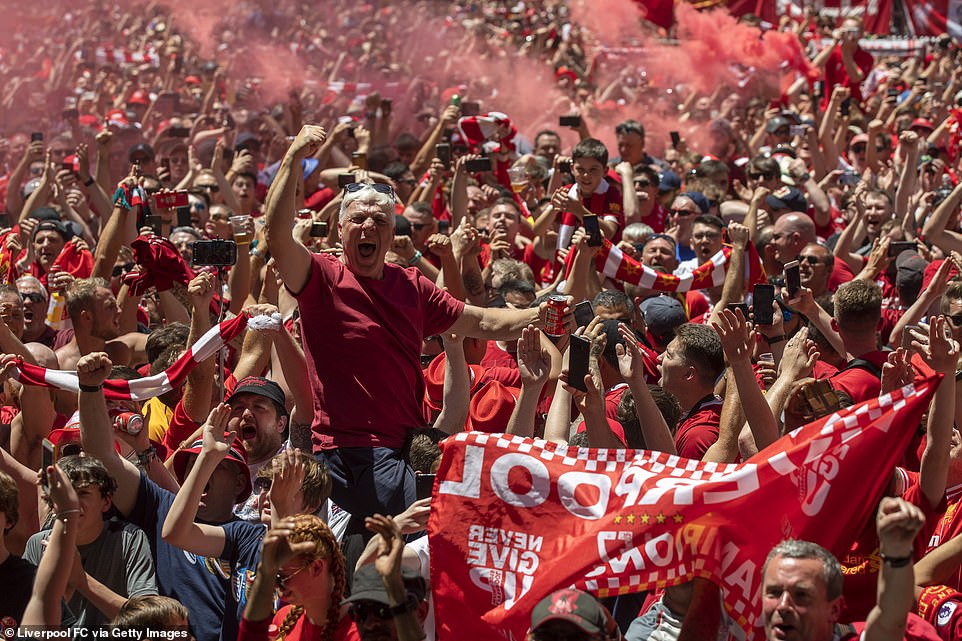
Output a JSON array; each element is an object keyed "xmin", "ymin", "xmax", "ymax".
[{"xmin": 238, "ymin": 514, "xmax": 356, "ymax": 641}]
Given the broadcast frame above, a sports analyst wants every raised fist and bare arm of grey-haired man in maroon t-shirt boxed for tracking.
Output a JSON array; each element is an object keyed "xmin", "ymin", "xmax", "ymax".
[{"xmin": 264, "ymin": 125, "xmax": 325, "ymax": 292}]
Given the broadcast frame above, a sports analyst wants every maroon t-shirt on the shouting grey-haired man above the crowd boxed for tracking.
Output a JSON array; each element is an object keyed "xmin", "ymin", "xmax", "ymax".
[{"xmin": 295, "ymin": 254, "xmax": 464, "ymax": 452}]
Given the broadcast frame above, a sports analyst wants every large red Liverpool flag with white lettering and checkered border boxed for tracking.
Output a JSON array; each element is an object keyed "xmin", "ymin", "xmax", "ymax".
[{"xmin": 428, "ymin": 377, "xmax": 940, "ymax": 640}]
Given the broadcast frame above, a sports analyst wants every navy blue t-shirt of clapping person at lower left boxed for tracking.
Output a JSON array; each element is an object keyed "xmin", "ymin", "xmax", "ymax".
[{"xmin": 126, "ymin": 473, "xmax": 266, "ymax": 641}]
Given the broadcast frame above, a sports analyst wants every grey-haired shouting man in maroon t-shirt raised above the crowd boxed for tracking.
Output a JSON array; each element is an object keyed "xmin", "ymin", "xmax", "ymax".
[{"xmin": 265, "ymin": 125, "xmax": 564, "ymax": 532}]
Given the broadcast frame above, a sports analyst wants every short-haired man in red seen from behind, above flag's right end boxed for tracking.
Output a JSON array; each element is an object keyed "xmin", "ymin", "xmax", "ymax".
[{"xmin": 829, "ymin": 280, "xmax": 888, "ymax": 403}]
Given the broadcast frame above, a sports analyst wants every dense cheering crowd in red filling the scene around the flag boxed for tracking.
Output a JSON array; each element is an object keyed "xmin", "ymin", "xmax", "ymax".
[{"xmin": 0, "ymin": 0, "xmax": 962, "ymax": 641}]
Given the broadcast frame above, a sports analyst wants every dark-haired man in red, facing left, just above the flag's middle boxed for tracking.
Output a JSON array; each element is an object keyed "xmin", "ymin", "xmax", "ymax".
[{"xmin": 658, "ymin": 323, "xmax": 725, "ymax": 460}]
